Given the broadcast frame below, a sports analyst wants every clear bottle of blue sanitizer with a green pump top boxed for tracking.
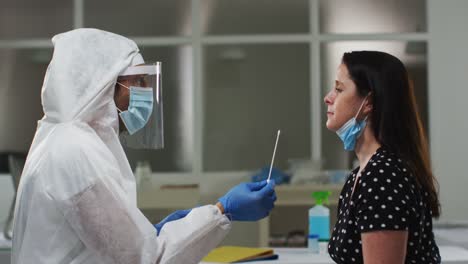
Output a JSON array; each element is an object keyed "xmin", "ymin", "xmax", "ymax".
[{"xmin": 309, "ymin": 191, "xmax": 331, "ymax": 241}]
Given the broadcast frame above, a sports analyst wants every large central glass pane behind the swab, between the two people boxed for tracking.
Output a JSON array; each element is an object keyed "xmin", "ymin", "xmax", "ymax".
[{"xmin": 203, "ymin": 44, "xmax": 311, "ymax": 171}]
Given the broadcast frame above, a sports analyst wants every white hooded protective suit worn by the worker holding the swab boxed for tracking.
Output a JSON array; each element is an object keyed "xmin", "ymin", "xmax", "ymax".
[{"xmin": 12, "ymin": 29, "xmax": 231, "ymax": 264}]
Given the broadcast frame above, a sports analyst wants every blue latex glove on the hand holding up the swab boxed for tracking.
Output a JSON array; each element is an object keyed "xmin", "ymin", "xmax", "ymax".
[{"xmin": 218, "ymin": 180, "xmax": 276, "ymax": 221}]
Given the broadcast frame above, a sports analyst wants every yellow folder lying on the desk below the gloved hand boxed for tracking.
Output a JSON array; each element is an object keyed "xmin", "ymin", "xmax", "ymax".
[{"xmin": 202, "ymin": 246, "xmax": 278, "ymax": 263}]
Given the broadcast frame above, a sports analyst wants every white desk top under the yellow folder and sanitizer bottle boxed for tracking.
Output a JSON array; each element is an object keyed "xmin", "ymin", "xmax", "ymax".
[{"xmin": 200, "ymin": 246, "xmax": 468, "ymax": 264}]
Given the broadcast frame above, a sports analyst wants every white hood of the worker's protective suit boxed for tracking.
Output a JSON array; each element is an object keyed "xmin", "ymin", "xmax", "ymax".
[{"xmin": 42, "ymin": 29, "xmax": 143, "ymax": 129}]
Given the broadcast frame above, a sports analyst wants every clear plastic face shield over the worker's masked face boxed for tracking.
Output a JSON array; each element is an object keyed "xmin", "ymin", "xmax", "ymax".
[{"xmin": 117, "ymin": 62, "xmax": 164, "ymax": 149}]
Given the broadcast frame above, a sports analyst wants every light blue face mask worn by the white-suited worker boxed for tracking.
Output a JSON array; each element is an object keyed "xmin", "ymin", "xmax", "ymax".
[{"xmin": 117, "ymin": 83, "xmax": 153, "ymax": 135}]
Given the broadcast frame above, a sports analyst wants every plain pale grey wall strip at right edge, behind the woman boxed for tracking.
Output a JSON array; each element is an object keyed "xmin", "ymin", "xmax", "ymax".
[{"xmin": 428, "ymin": 0, "xmax": 468, "ymax": 222}]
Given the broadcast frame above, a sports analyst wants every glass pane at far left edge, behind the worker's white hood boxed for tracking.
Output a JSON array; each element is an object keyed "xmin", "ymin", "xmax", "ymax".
[{"xmin": 0, "ymin": 49, "xmax": 52, "ymax": 153}]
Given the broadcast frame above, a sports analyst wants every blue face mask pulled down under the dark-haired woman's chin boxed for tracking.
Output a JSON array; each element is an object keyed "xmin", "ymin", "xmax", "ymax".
[{"xmin": 336, "ymin": 99, "xmax": 367, "ymax": 151}]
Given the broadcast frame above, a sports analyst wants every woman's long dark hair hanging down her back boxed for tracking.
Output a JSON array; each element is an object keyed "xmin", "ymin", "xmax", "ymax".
[{"xmin": 342, "ymin": 51, "xmax": 440, "ymax": 217}]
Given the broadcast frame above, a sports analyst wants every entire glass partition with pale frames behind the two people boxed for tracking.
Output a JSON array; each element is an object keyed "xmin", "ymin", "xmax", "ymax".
[{"xmin": 0, "ymin": 0, "xmax": 430, "ymax": 173}]
